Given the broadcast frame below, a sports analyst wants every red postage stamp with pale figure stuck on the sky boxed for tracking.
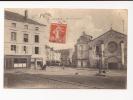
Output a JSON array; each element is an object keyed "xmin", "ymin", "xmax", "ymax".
[{"xmin": 49, "ymin": 23, "xmax": 67, "ymax": 43}]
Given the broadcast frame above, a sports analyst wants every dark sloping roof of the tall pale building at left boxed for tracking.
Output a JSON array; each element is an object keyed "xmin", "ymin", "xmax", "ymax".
[{"xmin": 5, "ymin": 11, "xmax": 46, "ymax": 26}]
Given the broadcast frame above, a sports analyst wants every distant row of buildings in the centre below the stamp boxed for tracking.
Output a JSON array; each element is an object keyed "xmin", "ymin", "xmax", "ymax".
[{"xmin": 45, "ymin": 45, "xmax": 73, "ymax": 66}]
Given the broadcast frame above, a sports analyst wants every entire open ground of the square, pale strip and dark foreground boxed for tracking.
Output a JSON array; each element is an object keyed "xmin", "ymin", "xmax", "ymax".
[{"xmin": 4, "ymin": 66, "xmax": 127, "ymax": 89}]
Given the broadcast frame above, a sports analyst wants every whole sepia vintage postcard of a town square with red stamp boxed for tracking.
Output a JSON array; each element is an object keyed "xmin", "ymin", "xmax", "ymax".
[{"xmin": 3, "ymin": 8, "xmax": 128, "ymax": 89}]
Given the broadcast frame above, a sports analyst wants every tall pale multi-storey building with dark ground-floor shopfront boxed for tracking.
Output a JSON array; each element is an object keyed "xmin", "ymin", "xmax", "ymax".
[{"xmin": 4, "ymin": 10, "xmax": 46, "ymax": 69}]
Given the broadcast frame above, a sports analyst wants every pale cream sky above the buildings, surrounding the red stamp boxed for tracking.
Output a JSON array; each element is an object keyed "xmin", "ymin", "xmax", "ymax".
[{"xmin": 7, "ymin": 8, "xmax": 128, "ymax": 49}]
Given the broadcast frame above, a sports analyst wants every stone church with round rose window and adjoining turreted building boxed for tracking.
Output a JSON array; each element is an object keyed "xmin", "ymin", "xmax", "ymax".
[{"xmin": 75, "ymin": 29, "xmax": 127, "ymax": 69}]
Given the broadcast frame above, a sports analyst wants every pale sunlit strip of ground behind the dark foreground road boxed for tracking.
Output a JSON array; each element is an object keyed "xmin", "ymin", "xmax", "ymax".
[{"xmin": 5, "ymin": 66, "xmax": 126, "ymax": 76}]
